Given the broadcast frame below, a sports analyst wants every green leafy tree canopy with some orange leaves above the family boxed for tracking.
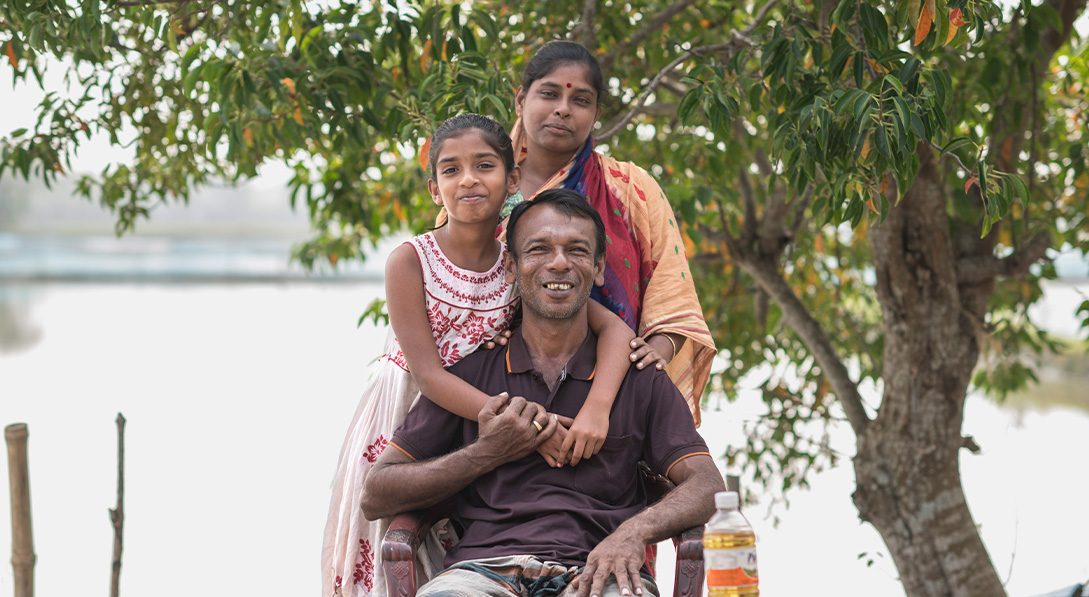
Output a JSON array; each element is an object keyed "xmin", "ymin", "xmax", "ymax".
[{"xmin": 0, "ymin": 0, "xmax": 1089, "ymax": 509}]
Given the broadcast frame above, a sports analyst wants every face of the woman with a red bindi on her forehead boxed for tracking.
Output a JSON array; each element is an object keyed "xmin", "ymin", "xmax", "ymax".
[{"xmin": 514, "ymin": 62, "xmax": 601, "ymax": 157}]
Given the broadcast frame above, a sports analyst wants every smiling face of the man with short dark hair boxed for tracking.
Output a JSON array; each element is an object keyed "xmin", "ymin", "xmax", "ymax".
[{"xmin": 506, "ymin": 205, "xmax": 605, "ymax": 319}]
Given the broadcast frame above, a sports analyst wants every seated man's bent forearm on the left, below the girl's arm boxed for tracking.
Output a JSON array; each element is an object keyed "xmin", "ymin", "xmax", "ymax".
[{"xmin": 360, "ymin": 443, "xmax": 501, "ymax": 521}]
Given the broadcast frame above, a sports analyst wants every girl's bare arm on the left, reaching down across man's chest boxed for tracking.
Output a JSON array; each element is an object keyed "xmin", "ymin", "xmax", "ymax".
[{"xmin": 386, "ymin": 244, "xmax": 488, "ymax": 421}]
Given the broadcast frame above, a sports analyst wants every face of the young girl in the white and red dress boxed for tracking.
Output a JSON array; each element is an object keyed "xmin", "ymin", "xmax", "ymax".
[{"xmin": 427, "ymin": 129, "xmax": 519, "ymax": 226}]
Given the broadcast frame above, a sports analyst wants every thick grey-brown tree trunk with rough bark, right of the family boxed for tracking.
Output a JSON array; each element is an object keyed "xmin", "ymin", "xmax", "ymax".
[{"xmin": 854, "ymin": 146, "xmax": 1005, "ymax": 597}]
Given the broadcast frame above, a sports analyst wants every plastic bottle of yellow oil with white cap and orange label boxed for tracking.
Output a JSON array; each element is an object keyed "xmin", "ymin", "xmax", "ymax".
[{"xmin": 703, "ymin": 491, "xmax": 760, "ymax": 597}]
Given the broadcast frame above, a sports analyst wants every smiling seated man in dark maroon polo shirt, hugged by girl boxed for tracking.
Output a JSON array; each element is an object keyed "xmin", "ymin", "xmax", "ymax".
[{"xmin": 362, "ymin": 190, "xmax": 725, "ymax": 597}]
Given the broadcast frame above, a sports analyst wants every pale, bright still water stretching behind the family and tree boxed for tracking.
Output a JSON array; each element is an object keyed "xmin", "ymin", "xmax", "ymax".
[{"xmin": 0, "ymin": 276, "xmax": 1089, "ymax": 597}]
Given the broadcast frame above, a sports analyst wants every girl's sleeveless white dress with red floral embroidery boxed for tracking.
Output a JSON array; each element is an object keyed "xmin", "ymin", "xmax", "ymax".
[{"xmin": 321, "ymin": 232, "xmax": 518, "ymax": 597}]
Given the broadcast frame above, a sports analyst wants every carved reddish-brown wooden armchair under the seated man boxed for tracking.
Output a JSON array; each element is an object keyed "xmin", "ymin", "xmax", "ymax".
[{"xmin": 382, "ymin": 463, "xmax": 737, "ymax": 597}]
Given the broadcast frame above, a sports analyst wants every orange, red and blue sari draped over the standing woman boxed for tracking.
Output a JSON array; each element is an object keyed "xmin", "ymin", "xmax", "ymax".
[{"xmin": 503, "ymin": 119, "xmax": 715, "ymax": 425}]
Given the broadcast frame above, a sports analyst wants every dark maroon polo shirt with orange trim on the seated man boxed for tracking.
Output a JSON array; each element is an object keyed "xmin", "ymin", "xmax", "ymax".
[{"xmin": 390, "ymin": 329, "xmax": 708, "ymax": 566}]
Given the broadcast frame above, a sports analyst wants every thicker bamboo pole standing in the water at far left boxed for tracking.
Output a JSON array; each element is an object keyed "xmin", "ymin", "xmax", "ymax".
[{"xmin": 3, "ymin": 423, "xmax": 37, "ymax": 597}]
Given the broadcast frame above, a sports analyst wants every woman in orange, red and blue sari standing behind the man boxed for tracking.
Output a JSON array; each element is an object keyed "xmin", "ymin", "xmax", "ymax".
[{"xmin": 503, "ymin": 41, "xmax": 715, "ymax": 425}]
